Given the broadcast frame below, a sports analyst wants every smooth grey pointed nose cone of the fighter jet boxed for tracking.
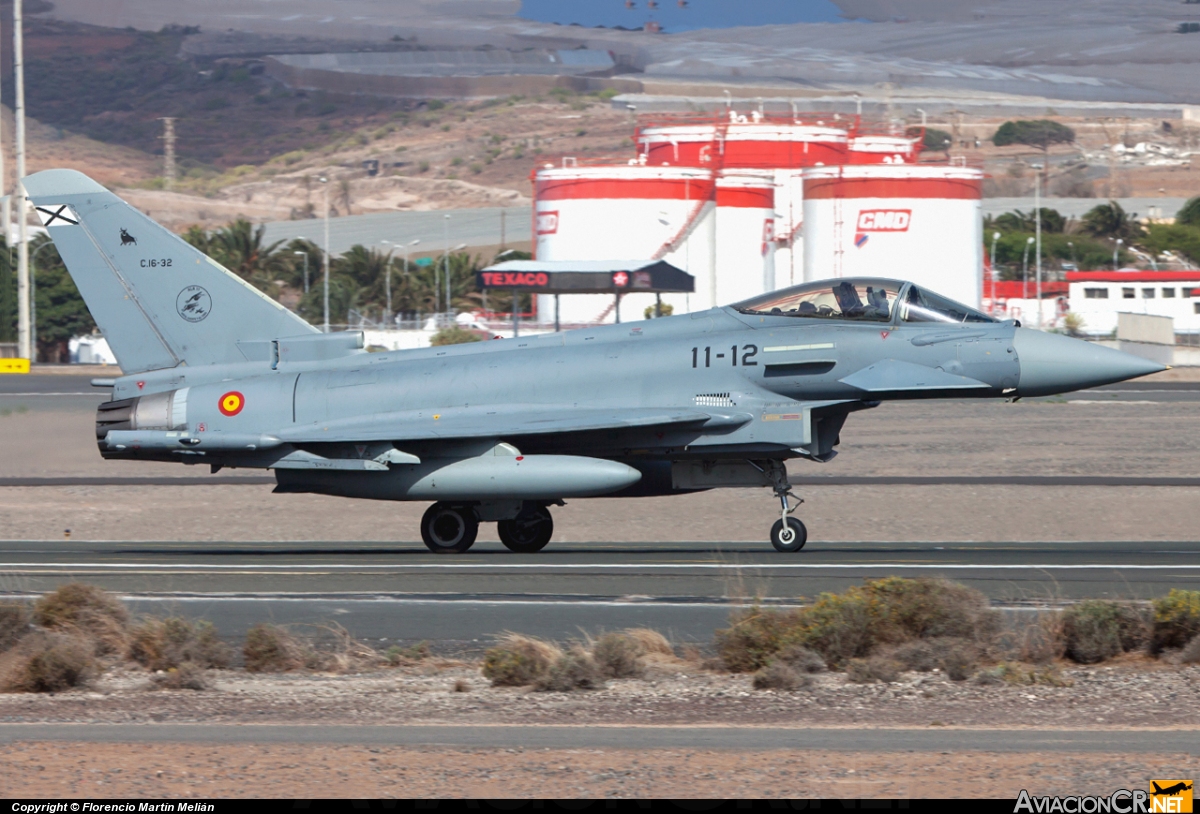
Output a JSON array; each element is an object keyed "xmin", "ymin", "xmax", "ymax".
[{"xmin": 1013, "ymin": 328, "xmax": 1166, "ymax": 396}]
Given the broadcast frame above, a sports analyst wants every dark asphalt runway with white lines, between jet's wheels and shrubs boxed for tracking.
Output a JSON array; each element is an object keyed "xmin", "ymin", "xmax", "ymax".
[{"xmin": 0, "ymin": 540, "xmax": 1200, "ymax": 650}]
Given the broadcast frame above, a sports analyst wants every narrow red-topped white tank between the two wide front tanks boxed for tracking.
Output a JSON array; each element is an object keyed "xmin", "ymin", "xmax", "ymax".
[{"xmin": 716, "ymin": 169, "xmax": 778, "ymax": 305}]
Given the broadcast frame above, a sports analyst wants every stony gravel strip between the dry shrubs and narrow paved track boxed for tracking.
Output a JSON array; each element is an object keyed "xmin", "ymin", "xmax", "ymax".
[{"xmin": 0, "ymin": 657, "xmax": 1200, "ymax": 729}]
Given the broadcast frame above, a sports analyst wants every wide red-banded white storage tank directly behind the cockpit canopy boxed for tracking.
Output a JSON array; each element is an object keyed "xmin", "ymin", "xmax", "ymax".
[{"xmin": 804, "ymin": 164, "xmax": 983, "ymax": 307}]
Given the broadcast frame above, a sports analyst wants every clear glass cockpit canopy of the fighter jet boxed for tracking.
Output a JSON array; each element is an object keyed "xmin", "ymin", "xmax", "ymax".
[{"xmin": 732, "ymin": 277, "xmax": 997, "ymax": 323}]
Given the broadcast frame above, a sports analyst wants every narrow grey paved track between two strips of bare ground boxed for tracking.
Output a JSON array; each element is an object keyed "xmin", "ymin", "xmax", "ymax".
[{"xmin": 0, "ymin": 724, "xmax": 1200, "ymax": 755}]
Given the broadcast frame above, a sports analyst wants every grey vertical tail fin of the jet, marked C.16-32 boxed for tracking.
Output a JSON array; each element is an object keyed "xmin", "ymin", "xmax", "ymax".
[{"xmin": 24, "ymin": 169, "xmax": 317, "ymax": 373}]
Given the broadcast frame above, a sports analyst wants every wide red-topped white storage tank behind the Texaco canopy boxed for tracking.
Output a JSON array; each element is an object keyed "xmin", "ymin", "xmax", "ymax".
[{"xmin": 534, "ymin": 162, "xmax": 715, "ymax": 324}]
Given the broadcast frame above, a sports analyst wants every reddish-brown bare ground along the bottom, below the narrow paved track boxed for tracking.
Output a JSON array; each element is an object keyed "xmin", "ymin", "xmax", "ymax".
[{"xmin": 0, "ymin": 743, "xmax": 1196, "ymax": 800}]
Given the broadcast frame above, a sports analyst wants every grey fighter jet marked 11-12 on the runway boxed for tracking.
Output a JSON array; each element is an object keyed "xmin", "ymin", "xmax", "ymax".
[{"xmin": 25, "ymin": 169, "xmax": 1163, "ymax": 552}]
